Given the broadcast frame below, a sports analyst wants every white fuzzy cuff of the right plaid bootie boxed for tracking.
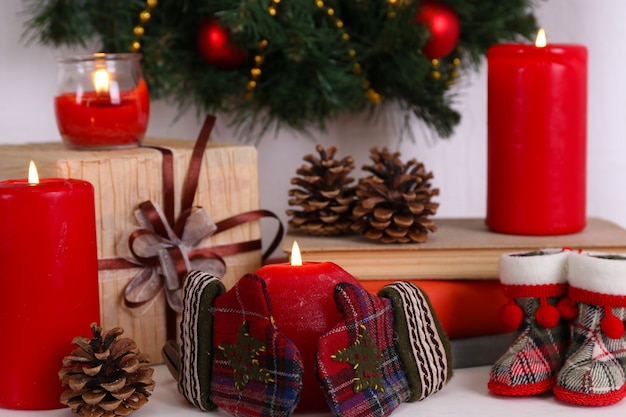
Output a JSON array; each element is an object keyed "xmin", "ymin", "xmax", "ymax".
[{"xmin": 568, "ymin": 252, "xmax": 626, "ymax": 296}]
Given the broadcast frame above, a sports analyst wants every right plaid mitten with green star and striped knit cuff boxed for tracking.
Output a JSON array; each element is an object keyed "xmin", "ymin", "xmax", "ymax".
[{"xmin": 317, "ymin": 283, "xmax": 451, "ymax": 417}]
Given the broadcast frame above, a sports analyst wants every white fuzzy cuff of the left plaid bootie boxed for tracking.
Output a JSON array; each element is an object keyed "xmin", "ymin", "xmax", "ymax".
[{"xmin": 499, "ymin": 249, "xmax": 571, "ymax": 285}]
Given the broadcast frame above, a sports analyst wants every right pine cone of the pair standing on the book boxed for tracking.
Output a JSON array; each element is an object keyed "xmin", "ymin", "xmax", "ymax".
[{"xmin": 352, "ymin": 148, "xmax": 439, "ymax": 243}]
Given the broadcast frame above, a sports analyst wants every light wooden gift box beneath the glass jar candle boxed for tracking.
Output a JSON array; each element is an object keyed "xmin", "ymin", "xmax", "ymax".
[{"xmin": 0, "ymin": 138, "xmax": 261, "ymax": 363}]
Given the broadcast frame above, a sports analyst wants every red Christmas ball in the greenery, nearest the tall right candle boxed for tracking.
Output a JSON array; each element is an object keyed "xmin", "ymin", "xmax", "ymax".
[{"xmin": 413, "ymin": 0, "xmax": 461, "ymax": 59}]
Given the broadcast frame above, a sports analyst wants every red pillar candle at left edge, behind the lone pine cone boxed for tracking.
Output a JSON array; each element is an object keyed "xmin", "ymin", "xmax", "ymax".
[{"xmin": 0, "ymin": 179, "xmax": 100, "ymax": 414}]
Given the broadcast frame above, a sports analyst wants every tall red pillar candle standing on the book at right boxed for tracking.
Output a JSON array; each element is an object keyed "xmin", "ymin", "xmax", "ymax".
[{"xmin": 486, "ymin": 30, "xmax": 587, "ymax": 235}]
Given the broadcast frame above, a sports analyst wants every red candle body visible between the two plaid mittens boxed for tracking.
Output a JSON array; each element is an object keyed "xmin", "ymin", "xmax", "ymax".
[{"xmin": 256, "ymin": 262, "xmax": 360, "ymax": 412}]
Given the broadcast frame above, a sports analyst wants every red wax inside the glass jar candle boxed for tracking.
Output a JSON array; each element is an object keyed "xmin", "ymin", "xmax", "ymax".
[{"xmin": 54, "ymin": 78, "xmax": 150, "ymax": 148}]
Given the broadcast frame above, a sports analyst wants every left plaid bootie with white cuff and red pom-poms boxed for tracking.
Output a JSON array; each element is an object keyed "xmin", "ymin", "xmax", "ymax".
[{"xmin": 488, "ymin": 249, "xmax": 575, "ymax": 396}]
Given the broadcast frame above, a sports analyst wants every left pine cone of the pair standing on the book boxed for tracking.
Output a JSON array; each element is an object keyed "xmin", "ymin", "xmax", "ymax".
[{"xmin": 287, "ymin": 145, "xmax": 355, "ymax": 236}]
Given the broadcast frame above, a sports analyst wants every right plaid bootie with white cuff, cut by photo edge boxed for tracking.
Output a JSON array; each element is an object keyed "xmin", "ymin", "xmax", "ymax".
[{"xmin": 554, "ymin": 253, "xmax": 626, "ymax": 406}]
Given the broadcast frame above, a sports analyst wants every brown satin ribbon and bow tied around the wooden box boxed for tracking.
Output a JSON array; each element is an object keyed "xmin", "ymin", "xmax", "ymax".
[{"xmin": 98, "ymin": 114, "xmax": 284, "ymax": 339}]
